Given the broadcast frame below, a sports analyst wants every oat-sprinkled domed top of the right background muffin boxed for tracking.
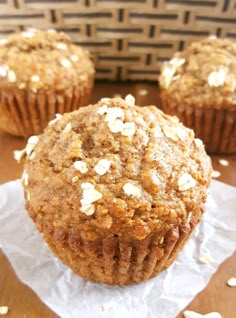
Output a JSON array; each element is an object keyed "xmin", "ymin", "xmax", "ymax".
[{"xmin": 159, "ymin": 37, "xmax": 236, "ymax": 109}]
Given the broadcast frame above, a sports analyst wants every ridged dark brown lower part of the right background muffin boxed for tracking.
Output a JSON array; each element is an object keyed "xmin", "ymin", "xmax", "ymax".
[{"xmin": 161, "ymin": 92, "xmax": 236, "ymax": 154}]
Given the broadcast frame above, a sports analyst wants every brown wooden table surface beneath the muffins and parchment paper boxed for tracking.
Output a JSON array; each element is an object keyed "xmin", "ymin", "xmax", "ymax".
[{"xmin": 0, "ymin": 82, "xmax": 236, "ymax": 318}]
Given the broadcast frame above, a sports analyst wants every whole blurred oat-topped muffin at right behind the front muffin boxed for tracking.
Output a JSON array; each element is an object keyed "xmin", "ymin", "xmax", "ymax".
[{"xmin": 159, "ymin": 37, "xmax": 236, "ymax": 153}]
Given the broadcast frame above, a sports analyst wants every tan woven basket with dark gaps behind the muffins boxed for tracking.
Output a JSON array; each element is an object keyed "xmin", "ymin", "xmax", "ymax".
[{"xmin": 0, "ymin": 0, "xmax": 236, "ymax": 80}]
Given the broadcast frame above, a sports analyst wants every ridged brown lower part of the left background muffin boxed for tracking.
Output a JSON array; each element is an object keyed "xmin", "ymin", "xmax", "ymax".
[{"xmin": 0, "ymin": 77, "xmax": 93, "ymax": 137}]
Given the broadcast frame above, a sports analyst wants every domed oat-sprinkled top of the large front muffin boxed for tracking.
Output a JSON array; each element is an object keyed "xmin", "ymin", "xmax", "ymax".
[{"xmin": 17, "ymin": 95, "xmax": 211, "ymax": 240}]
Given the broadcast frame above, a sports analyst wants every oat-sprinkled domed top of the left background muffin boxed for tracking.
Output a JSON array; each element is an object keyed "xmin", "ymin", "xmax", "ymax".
[{"xmin": 0, "ymin": 29, "xmax": 94, "ymax": 93}]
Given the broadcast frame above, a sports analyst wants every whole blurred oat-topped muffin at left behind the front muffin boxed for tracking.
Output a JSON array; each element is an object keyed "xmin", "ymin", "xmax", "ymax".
[{"xmin": 0, "ymin": 29, "xmax": 94, "ymax": 136}]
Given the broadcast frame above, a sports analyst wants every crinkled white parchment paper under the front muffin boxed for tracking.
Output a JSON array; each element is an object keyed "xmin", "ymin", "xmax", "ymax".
[{"xmin": 0, "ymin": 180, "xmax": 236, "ymax": 318}]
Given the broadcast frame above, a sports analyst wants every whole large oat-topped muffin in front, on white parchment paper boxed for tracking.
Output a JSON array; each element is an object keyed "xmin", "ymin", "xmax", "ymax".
[{"xmin": 17, "ymin": 95, "xmax": 211, "ymax": 285}]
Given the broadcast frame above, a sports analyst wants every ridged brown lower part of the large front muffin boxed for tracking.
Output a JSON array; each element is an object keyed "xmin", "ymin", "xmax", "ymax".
[{"xmin": 41, "ymin": 209, "xmax": 202, "ymax": 285}]
